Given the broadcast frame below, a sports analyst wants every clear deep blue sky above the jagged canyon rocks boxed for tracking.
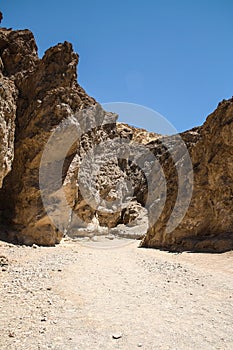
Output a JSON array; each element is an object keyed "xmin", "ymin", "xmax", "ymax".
[{"xmin": 0, "ymin": 0, "xmax": 233, "ymax": 131}]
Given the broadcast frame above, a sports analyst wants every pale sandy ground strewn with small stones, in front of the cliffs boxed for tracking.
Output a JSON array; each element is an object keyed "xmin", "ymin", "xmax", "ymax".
[{"xmin": 0, "ymin": 240, "xmax": 233, "ymax": 350}]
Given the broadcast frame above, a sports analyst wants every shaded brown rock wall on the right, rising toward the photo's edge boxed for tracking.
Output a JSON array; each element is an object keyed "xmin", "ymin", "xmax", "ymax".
[{"xmin": 142, "ymin": 98, "xmax": 233, "ymax": 252}]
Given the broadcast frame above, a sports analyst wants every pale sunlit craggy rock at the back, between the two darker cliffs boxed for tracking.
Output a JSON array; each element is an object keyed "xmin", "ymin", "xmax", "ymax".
[{"xmin": 64, "ymin": 105, "xmax": 156, "ymax": 237}]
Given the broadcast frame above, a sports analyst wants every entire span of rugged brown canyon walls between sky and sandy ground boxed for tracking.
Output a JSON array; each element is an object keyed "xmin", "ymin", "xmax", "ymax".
[{"xmin": 0, "ymin": 28, "xmax": 233, "ymax": 251}]
